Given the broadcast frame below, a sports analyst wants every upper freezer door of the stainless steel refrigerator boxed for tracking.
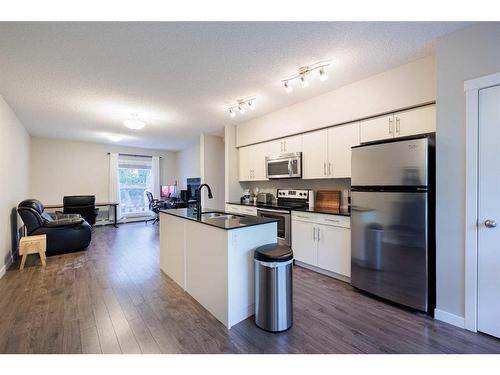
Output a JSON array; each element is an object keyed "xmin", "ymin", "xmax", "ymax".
[{"xmin": 351, "ymin": 138, "xmax": 429, "ymax": 186}]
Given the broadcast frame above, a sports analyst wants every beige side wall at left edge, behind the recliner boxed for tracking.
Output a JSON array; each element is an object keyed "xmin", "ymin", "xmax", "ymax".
[{"xmin": 0, "ymin": 95, "xmax": 30, "ymax": 277}]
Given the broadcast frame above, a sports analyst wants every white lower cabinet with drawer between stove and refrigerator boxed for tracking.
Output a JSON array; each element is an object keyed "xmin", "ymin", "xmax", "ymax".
[{"xmin": 292, "ymin": 212, "xmax": 351, "ymax": 277}]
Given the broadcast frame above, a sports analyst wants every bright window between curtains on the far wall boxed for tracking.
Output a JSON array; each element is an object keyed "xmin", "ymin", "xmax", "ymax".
[{"xmin": 118, "ymin": 155, "xmax": 153, "ymax": 217}]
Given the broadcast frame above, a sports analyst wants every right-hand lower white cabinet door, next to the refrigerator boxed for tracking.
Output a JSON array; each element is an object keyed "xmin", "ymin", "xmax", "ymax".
[{"xmin": 317, "ymin": 225, "xmax": 351, "ymax": 277}]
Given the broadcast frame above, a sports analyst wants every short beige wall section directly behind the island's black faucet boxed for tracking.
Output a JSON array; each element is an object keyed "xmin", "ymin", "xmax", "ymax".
[{"xmin": 200, "ymin": 134, "xmax": 225, "ymax": 210}]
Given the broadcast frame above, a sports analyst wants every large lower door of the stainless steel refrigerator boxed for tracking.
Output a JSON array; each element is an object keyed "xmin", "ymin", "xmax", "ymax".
[{"xmin": 351, "ymin": 191, "xmax": 428, "ymax": 311}]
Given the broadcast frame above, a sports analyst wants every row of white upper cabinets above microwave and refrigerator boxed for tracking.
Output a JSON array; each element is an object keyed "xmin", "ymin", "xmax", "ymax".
[{"xmin": 239, "ymin": 105, "xmax": 436, "ymax": 181}]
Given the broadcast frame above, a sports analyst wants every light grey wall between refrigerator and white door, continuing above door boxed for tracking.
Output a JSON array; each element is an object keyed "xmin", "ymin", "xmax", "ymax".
[{"xmin": 436, "ymin": 23, "xmax": 500, "ymax": 324}]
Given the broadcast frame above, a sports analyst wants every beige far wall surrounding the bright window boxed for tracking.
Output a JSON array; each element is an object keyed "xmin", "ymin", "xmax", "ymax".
[{"xmin": 31, "ymin": 137, "xmax": 176, "ymax": 204}]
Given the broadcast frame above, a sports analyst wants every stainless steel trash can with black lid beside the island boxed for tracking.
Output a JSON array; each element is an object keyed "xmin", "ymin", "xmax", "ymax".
[{"xmin": 254, "ymin": 244, "xmax": 293, "ymax": 332}]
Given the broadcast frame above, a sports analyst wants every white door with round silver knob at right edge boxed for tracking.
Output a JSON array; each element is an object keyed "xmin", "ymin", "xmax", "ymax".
[{"xmin": 477, "ymin": 86, "xmax": 500, "ymax": 337}]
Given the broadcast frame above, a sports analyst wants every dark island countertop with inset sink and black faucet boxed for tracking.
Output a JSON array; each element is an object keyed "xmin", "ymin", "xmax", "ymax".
[{"xmin": 160, "ymin": 208, "xmax": 278, "ymax": 230}]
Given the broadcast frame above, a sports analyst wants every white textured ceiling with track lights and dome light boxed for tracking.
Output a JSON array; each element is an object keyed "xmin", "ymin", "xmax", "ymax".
[{"xmin": 0, "ymin": 22, "xmax": 467, "ymax": 150}]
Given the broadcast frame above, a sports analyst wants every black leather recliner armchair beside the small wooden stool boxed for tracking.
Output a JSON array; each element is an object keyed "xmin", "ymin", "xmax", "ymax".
[{"xmin": 17, "ymin": 199, "xmax": 92, "ymax": 255}]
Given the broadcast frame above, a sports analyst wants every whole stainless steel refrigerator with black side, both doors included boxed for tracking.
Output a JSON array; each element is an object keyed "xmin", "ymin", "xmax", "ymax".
[{"xmin": 351, "ymin": 134, "xmax": 435, "ymax": 315}]
